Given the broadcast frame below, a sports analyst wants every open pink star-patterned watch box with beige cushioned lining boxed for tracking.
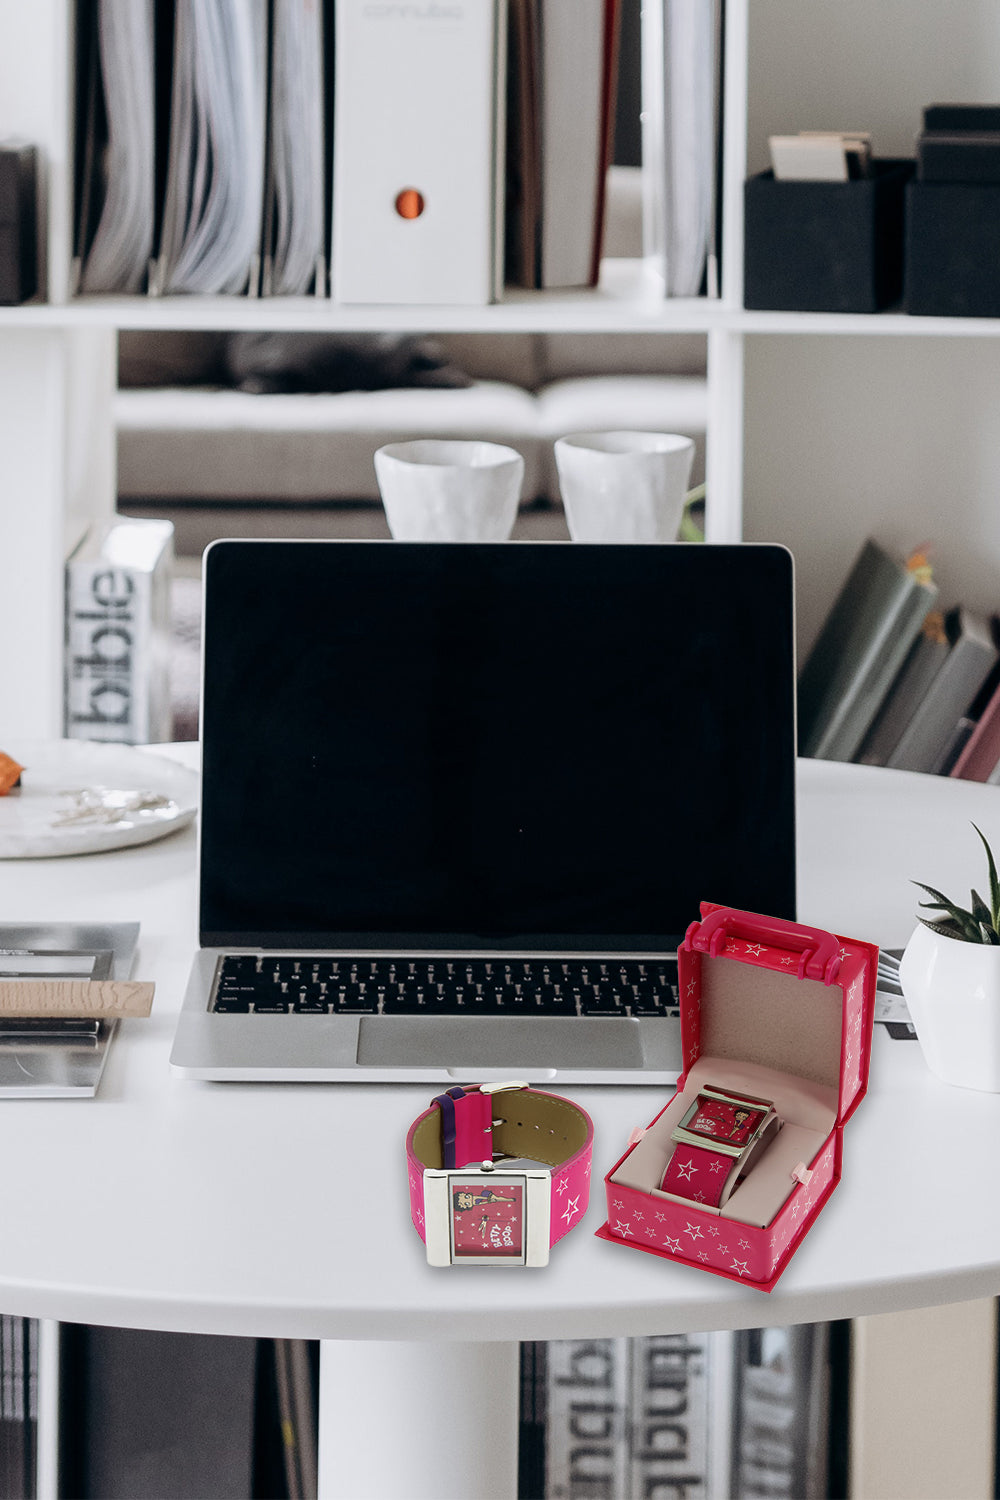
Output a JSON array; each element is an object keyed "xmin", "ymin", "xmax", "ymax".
[{"xmin": 597, "ymin": 905, "xmax": 879, "ymax": 1292}]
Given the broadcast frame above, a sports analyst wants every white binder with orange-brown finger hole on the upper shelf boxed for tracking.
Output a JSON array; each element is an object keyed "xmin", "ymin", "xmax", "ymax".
[{"xmin": 331, "ymin": 0, "xmax": 507, "ymax": 305}]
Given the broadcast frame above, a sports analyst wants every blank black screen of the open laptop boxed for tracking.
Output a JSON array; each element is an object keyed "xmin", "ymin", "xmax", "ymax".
[{"xmin": 201, "ymin": 542, "xmax": 795, "ymax": 951}]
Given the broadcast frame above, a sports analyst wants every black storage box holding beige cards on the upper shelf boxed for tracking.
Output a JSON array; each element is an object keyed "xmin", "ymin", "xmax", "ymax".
[{"xmin": 744, "ymin": 161, "xmax": 913, "ymax": 312}]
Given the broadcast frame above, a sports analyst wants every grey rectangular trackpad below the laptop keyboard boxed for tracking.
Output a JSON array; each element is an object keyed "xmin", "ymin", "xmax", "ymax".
[{"xmin": 358, "ymin": 1016, "xmax": 643, "ymax": 1068}]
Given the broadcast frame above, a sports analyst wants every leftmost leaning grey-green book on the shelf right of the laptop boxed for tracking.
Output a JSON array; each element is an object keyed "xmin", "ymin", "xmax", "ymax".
[{"xmin": 798, "ymin": 539, "xmax": 937, "ymax": 761}]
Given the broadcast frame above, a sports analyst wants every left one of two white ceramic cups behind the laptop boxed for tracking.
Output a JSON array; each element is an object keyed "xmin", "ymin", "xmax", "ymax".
[{"xmin": 375, "ymin": 438, "xmax": 525, "ymax": 542}]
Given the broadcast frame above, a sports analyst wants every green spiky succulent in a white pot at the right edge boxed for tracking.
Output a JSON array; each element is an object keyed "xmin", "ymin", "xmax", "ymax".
[{"xmin": 900, "ymin": 824, "xmax": 1000, "ymax": 1094}]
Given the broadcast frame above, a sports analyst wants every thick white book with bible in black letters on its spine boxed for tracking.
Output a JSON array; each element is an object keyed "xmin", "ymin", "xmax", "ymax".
[{"xmin": 63, "ymin": 558, "xmax": 171, "ymax": 744}]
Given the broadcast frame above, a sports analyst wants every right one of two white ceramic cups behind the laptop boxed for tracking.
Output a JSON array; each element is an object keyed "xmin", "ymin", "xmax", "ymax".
[{"xmin": 555, "ymin": 432, "xmax": 694, "ymax": 542}]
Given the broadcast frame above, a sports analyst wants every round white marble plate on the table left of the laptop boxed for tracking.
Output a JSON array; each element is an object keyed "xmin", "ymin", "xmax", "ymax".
[{"xmin": 0, "ymin": 740, "xmax": 199, "ymax": 860}]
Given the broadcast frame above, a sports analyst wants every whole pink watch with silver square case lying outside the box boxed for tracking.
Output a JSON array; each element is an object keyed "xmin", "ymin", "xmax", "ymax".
[{"xmin": 406, "ymin": 1082, "xmax": 594, "ymax": 1266}]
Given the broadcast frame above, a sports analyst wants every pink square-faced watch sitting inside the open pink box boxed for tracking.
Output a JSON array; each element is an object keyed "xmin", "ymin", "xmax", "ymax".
[{"xmin": 660, "ymin": 1088, "xmax": 781, "ymax": 1209}]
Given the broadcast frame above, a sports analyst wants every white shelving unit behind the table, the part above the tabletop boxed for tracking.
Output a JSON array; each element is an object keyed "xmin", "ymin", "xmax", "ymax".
[{"xmin": 0, "ymin": 0, "xmax": 1000, "ymax": 735}]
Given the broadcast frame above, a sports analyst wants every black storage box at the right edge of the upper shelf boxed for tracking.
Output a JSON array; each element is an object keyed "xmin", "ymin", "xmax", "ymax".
[{"xmin": 906, "ymin": 182, "xmax": 1000, "ymax": 318}]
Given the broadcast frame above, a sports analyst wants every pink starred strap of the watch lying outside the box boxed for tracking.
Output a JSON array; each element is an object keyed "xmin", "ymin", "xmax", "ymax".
[{"xmin": 406, "ymin": 1088, "xmax": 594, "ymax": 1247}]
